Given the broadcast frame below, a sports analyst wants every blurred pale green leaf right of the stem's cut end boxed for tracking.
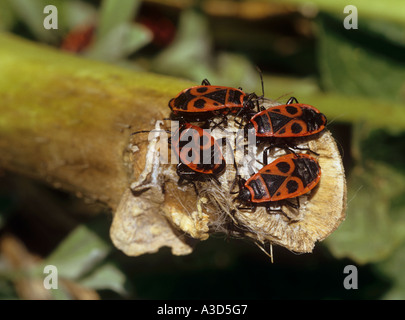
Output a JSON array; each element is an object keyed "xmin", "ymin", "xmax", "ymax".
[{"xmin": 326, "ymin": 160, "xmax": 405, "ymax": 264}]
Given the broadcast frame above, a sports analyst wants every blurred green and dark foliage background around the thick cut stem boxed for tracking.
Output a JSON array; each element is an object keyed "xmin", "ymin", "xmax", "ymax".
[{"xmin": 0, "ymin": 0, "xmax": 405, "ymax": 299}]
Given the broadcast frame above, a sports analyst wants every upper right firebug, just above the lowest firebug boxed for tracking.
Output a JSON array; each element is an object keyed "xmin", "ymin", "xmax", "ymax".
[{"xmin": 245, "ymin": 97, "xmax": 327, "ymax": 138}]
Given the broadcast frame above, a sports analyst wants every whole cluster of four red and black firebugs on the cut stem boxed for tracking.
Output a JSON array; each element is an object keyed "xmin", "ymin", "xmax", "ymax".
[{"xmin": 133, "ymin": 74, "xmax": 327, "ymax": 220}]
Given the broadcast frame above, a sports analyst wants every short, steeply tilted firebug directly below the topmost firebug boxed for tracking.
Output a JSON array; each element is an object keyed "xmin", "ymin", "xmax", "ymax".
[{"xmin": 170, "ymin": 123, "xmax": 226, "ymax": 184}]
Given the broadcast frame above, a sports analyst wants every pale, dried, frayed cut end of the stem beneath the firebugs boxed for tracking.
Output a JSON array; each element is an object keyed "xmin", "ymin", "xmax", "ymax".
[{"xmin": 111, "ymin": 100, "xmax": 346, "ymax": 256}]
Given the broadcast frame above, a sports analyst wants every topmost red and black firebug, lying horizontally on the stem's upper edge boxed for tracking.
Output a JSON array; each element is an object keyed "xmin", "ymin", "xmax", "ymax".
[{"xmin": 169, "ymin": 79, "xmax": 263, "ymax": 121}]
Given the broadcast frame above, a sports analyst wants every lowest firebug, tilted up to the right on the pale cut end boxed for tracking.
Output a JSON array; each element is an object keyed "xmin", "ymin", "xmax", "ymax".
[{"xmin": 235, "ymin": 153, "xmax": 321, "ymax": 212}]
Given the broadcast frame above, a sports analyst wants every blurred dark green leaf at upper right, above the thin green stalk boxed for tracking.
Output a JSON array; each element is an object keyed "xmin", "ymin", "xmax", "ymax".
[{"xmin": 318, "ymin": 14, "xmax": 405, "ymax": 102}]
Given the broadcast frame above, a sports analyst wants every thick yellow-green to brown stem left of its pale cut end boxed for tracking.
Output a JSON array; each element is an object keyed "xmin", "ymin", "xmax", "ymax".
[{"xmin": 0, "ymin": 34, "xmax": 190, "ymax": 210}]
